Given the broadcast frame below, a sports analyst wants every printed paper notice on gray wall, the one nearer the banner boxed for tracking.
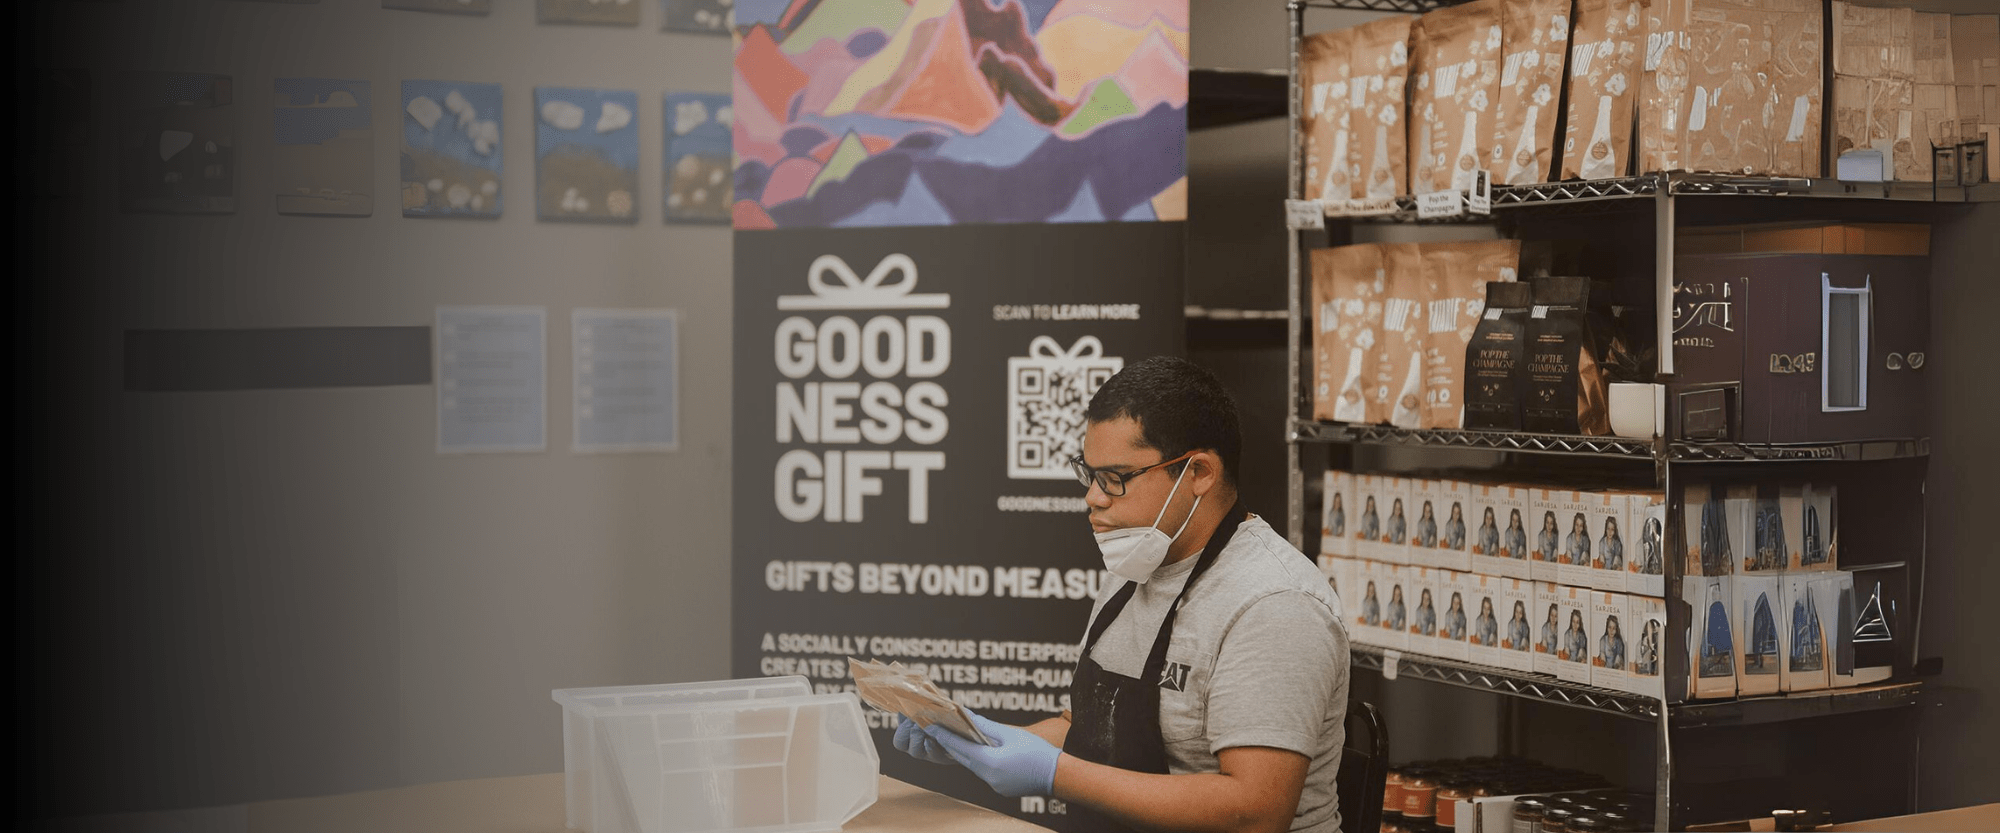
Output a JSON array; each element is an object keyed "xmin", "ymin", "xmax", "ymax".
[{"xmin": 570, "ymin": 308, "xmax": 680, "ymax": 453}]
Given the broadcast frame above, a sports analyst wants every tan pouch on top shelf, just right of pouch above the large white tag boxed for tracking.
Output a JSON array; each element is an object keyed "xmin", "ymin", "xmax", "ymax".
[{"xmin": 1486, "ymin": 0, "xmax": 1576, "ymax": 184}]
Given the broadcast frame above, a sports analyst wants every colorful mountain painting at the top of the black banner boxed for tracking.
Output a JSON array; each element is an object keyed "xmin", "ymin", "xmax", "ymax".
[{"xmin": 730, "ymin": 0, "xmax": 1188, "ymax": 228}]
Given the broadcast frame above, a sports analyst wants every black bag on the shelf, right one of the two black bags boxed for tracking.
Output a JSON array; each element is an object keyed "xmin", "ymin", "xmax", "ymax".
[{"xmin": 1522, "ymin": 276, "xmax": 1612, "ymax": 437}]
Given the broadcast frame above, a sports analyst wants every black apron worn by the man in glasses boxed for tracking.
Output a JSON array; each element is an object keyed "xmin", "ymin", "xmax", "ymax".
[{"xmin": 1062, "ymin": 503, "xmax": 1248, "ymax": 833}]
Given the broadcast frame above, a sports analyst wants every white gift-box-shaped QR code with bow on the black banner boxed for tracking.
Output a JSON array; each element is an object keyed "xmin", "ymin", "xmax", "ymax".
[{"xmin": 1006, "ymin": 336, "xmax": 1124, "ymax": 481}]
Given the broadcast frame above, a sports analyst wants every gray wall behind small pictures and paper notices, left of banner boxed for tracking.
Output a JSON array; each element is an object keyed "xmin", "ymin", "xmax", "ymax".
[{"xmin": 44, "ymin": 0, "xmax": 730, "ymax": 811}]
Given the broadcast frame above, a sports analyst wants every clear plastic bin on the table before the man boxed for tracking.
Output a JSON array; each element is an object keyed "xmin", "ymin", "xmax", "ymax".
[{"xmin": 554, "ymin": 677, "xmax": 882, "ymax": 833}]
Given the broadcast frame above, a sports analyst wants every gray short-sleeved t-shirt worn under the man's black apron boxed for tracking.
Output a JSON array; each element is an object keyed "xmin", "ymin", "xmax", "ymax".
[{"xmin": 1090, "ymin": 515, "xmax": 1350, "ymax": 833}]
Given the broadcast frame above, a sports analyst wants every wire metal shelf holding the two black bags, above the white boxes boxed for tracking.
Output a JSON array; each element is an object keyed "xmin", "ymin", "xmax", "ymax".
[{"xmin": 1292, "ymin": 421, "xmax": 1930, "ymax": 463}]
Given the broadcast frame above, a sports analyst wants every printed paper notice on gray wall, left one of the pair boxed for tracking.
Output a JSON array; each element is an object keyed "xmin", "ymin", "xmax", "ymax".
[{"xmin": 436, "ymin": 306, "xmax": 548, "ymax": 455}]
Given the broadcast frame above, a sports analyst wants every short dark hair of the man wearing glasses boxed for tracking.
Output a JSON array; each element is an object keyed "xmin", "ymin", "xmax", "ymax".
[{"xmin": 1084, "ymin": 356, "xmax": 1244, "ymax": 487}]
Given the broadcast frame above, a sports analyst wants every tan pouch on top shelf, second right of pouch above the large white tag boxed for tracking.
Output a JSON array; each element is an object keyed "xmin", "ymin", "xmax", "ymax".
[{"xmin": 1562, "ymin": 0, "xmax": 1646, "ymax": 180}]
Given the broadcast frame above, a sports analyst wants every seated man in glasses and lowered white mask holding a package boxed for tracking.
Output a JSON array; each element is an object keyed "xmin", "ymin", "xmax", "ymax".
[{"xmin": 896, "ymin": 358, "xmax": 1348, "ymax": 833}]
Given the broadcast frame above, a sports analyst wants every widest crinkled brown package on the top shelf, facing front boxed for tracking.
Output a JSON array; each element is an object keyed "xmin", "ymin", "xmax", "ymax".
[{"xmin": 1682, "ymin": 0, "xmax": 1826, "ymax": 176}]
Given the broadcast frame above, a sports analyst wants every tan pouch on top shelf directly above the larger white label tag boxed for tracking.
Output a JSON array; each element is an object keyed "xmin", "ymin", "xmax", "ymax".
[{"xmin": 1410, "ymin": 0, "xmax": 1500, "ymax": 194}]
